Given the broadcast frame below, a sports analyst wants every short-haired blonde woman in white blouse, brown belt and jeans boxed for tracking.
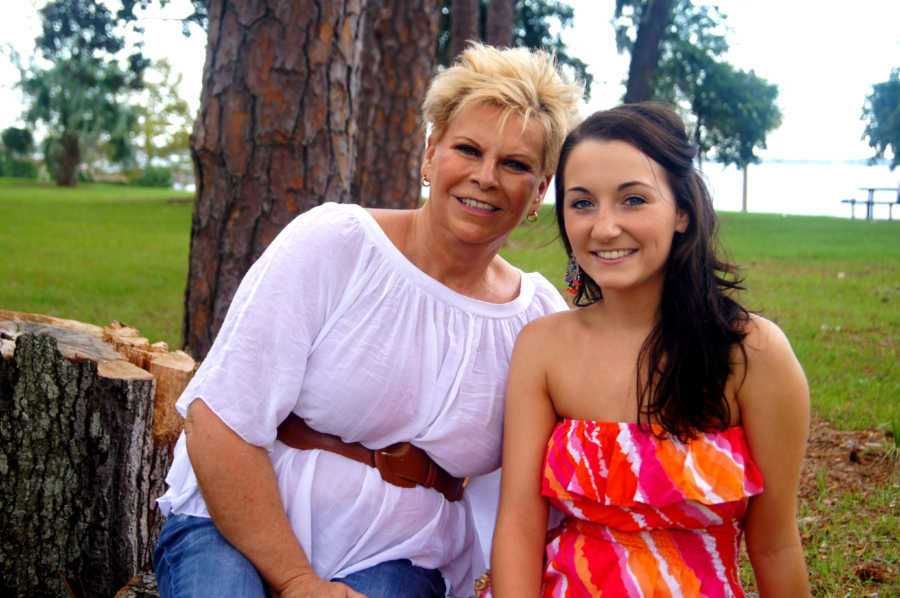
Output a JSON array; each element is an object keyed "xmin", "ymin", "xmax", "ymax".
[{"xmin": 154, "ymin": 45, "xmax": 581, "ymax": 598}]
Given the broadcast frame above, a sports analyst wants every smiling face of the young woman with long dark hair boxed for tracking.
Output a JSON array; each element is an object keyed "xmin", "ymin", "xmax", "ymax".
[{"xmin": 563, "ymin": 139, "xmax": 688, "ymax": 295}]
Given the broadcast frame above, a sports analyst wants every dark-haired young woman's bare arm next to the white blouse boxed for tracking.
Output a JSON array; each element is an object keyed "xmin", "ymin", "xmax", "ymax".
[{"xmin": 491, "ymin": 324, "xmax": 556, "ymax": 598}]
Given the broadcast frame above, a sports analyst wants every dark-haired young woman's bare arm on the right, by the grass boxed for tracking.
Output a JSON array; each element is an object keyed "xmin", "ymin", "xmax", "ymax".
[{"xmin": 738, "ymin": 318, "xmax": 809, "ymax": 598}]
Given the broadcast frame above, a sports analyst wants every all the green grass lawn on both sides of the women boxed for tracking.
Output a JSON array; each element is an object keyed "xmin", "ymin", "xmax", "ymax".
[{"xmin": 0, "ymin": 179, "xmax": 900, "ymax": 596}]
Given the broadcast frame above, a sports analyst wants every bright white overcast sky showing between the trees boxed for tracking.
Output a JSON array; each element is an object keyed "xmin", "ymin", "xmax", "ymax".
[{"xmin": 0, "ymin": 0, "xmax": 900, "ymax": 160}]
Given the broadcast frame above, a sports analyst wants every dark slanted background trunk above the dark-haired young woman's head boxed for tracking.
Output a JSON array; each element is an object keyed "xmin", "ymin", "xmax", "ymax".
[{"xmin": 625, "ymin": 0, "xmax": 673, "ymax": 104}]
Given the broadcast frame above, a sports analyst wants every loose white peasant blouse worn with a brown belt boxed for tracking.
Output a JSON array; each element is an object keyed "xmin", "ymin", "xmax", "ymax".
[{"xmin": 158, "ymin": 203, "xmax": 566, "ymax": 597}]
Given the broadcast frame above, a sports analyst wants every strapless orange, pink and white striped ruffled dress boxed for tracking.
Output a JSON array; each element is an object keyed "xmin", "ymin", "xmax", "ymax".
[{"xmin": 542, "ymin": 419, "xmax": 763, "ymax": 598}]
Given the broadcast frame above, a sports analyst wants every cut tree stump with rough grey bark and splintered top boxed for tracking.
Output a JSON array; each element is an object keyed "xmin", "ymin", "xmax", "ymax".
[{"xmin": 0, "ymin": 310, "xmax": 196, "ymax": 598}]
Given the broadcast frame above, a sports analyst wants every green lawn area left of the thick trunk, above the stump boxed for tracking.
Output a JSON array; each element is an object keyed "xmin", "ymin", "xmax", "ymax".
[{"xmin": 0, "ymin": 179, "xmax": 193, "ymax": 347}]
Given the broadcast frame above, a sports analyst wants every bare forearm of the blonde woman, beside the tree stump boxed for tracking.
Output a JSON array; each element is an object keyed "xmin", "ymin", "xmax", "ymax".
[{"xmin": 184, "ymin": 400, "xmax": 362, "ymax": 598}]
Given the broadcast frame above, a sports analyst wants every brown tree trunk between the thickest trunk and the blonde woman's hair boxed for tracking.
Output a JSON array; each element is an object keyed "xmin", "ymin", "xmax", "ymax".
[{"xmin": 351, "ymin": 0, "xmax": 440, "ymax": 208}]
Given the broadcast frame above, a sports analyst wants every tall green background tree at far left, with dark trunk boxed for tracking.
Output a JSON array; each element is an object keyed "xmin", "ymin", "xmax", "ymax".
[{"xmin": 20, "ymin": 0, "xmax": 147, "ymax": 186}]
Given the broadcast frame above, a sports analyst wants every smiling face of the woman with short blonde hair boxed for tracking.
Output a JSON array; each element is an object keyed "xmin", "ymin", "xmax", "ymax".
[{"xmin": 422, "ymin": 104, "xmax": 552, "ymax": 250}]
